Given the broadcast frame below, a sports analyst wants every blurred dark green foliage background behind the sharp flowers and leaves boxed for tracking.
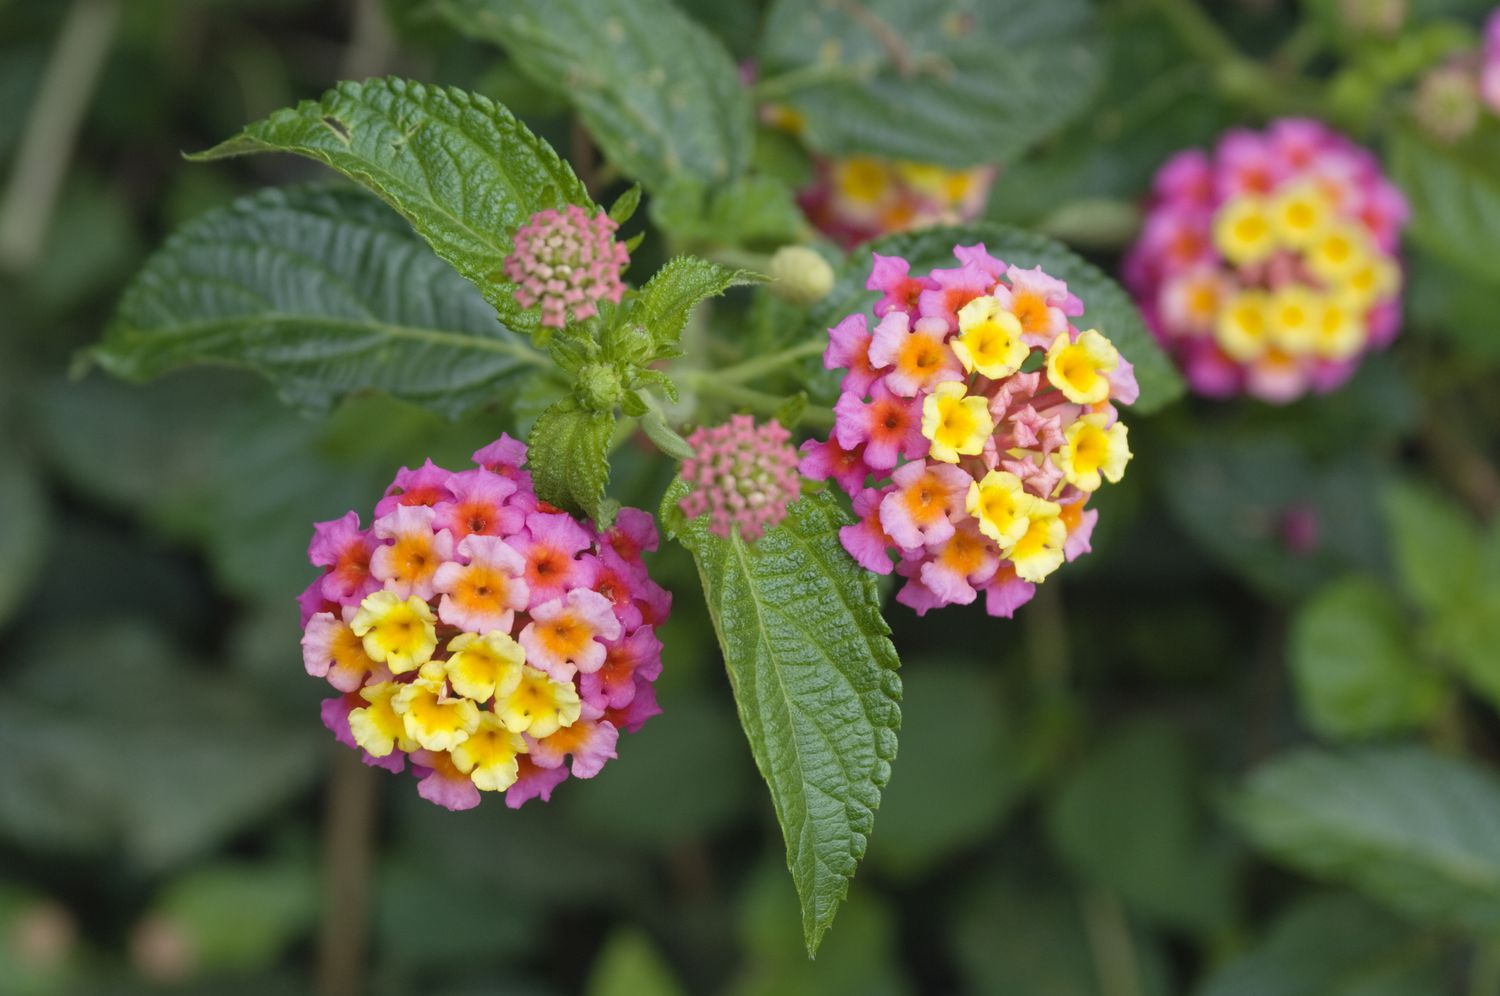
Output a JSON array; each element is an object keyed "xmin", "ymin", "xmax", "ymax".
[{"xmin": 0, "ymin": 0, "xmax": 1500, "ymax": 996}]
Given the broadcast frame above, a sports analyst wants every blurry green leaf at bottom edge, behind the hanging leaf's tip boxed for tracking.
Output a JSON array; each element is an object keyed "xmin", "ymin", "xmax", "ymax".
[{"xmin": 726, "ymin": 861, "xmax": 908, "ymax": 996}]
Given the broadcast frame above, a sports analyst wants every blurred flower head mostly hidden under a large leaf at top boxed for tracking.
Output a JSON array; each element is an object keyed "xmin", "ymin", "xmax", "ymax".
[{"xmin": 798, "ymin": 156, "xmax": 996, "ymax": 248}]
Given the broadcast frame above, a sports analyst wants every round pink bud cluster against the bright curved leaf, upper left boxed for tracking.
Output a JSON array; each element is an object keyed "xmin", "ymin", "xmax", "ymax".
[{"xmin": 506, "ymin": 204, "xmax": 630, "ymax": 329}]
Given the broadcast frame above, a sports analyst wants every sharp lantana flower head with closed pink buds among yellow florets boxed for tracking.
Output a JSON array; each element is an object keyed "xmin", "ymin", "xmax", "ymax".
[{"xmin": 801, "ymin": 245, "xmax": 1139, "ymax": 618}]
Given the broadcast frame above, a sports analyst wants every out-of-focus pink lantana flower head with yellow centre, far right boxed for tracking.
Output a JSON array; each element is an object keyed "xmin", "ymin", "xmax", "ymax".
[{"xmin": 1125, "ymin": 119, "xmax": 1407, "ymax": 402}]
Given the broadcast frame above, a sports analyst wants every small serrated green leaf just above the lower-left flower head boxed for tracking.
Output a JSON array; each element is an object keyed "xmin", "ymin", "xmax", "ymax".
[{"xmin": 527, "ymin": 399, "xmax": 615, "ymax": 521}]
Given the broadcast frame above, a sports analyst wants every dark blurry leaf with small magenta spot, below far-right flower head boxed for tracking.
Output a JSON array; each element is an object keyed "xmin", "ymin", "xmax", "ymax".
[{"xmin": 1163, "ymin": 432, "xmax": 1385, "ymax": 597}]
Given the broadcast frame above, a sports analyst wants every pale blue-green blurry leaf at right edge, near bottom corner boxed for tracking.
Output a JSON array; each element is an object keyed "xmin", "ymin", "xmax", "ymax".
[{"xmin": 1235, "ymin": 747, "xmax": 1500, "ymax": 932}]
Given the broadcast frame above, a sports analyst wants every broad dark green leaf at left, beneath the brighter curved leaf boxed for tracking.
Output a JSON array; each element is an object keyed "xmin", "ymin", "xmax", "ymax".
[{"xmin": 95, "ymin": 188, "xmax": 548, "ymax": 414}]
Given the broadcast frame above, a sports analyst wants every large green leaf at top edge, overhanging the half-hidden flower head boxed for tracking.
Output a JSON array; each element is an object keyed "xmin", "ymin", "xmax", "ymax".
[{"xmin": 761, "ymin": 0, "xmax": 1101, "ymax": 167}]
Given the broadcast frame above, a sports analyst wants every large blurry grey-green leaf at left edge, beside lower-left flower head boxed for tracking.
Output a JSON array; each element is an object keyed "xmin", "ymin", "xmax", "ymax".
[{"xmin": 0, "ymin": 623, "xmax": 323, "ymax": 870}]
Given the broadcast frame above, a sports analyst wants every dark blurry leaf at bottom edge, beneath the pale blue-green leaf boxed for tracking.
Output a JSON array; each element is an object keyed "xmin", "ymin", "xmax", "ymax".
[{"xmin": 1197, "ymin": 894, "xmax": 1449, "ymax": 996}]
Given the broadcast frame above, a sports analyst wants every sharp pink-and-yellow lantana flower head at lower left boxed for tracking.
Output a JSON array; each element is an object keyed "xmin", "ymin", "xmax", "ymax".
[{"xmin": 300, "ymin": 435, "xmax": 672, "ymax": 810}]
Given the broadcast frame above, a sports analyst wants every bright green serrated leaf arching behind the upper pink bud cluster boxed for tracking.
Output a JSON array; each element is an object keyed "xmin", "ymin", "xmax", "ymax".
[{"xmin": 192, "ymin": 80, "xmax": 593, "ymax": 329}]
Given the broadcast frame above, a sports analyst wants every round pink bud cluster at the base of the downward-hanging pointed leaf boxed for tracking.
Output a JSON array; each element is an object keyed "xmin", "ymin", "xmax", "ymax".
[{"xmin": 678, "ymin": 416, "xmax": 803, "ymax": 540}]
